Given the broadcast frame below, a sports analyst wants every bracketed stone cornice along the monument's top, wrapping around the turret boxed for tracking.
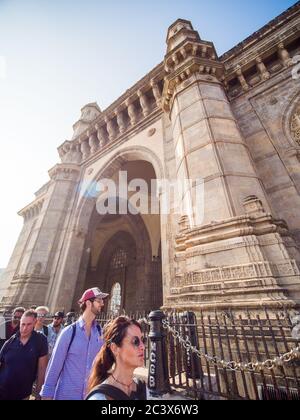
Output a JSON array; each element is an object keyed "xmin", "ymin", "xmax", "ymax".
[{"xmin": 58, "ymin": 4, "xmax": 300, "ymax": 164}]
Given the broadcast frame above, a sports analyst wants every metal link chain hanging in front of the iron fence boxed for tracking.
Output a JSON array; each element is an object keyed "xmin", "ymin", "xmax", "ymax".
[{"xmin": 162, "ymin": 320, "xmax": 300, "ymax": 372}]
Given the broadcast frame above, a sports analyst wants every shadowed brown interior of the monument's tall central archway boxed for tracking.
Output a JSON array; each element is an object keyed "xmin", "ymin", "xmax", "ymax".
[{"xmin": 81, "ymin": 161, "xmax": 163, "ymax": 313}]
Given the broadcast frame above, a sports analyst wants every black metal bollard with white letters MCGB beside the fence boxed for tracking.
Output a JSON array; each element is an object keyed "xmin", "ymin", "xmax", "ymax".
[{"xmin": 148, "ymin": 311, "xmax": 171, "ymax": 397}]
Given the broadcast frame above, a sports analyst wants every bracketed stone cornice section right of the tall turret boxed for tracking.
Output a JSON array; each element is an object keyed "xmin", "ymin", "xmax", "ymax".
[{"xmin": 220, "ymin": 3, "xmax": 300, "ymax": 99}]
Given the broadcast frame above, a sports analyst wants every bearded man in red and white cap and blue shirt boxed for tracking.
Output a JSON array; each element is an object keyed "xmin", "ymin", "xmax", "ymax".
[{"xmin": 41, "ymin": 287, "xmax": 108, "ymax": 400}]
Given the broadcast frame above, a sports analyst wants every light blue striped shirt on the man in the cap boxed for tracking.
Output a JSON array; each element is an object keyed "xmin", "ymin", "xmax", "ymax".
[{"xmin": 41, "ymin": 318, "xmax": 103, "ymax": 400}]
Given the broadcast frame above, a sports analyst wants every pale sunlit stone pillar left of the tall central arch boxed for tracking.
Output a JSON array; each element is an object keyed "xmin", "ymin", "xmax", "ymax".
[{"xmin": 0, "ymin": 164, "xmax": 80, "ymax": 309}]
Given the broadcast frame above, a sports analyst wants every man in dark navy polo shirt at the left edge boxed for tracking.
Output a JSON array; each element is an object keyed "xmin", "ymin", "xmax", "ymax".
[{"xmin": 0, "ymin": 311, "xmax": 48, "ymax": 400}]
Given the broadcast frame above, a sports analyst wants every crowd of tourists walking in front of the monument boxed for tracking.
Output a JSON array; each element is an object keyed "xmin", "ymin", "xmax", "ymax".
[{"xmin": 0, "ymin": 288, "xmax": 146, "ymax": 400}]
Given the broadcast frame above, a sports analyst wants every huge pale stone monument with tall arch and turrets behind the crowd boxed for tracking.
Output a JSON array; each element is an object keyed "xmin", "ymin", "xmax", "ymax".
[{"xmin": 0, "ymin": 2, "xmax": 300, "ymax": 313}]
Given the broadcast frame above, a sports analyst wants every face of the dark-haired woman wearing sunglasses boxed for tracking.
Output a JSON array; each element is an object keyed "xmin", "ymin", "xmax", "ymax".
[{"xmin": 117, "ymin": 325, "xmax": 145, "ymax": 369}]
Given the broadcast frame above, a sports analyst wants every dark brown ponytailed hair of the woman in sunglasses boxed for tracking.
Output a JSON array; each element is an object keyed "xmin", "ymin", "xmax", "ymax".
[{"xmin": 87, "ymin": 316, "xmax": 142, "ymax": 393}]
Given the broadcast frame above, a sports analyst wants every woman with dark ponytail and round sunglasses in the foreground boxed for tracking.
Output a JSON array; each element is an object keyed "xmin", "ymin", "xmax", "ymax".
[{"xmin": 86, "ymin": 316, "xmax": 147, "ymax": 400}]
